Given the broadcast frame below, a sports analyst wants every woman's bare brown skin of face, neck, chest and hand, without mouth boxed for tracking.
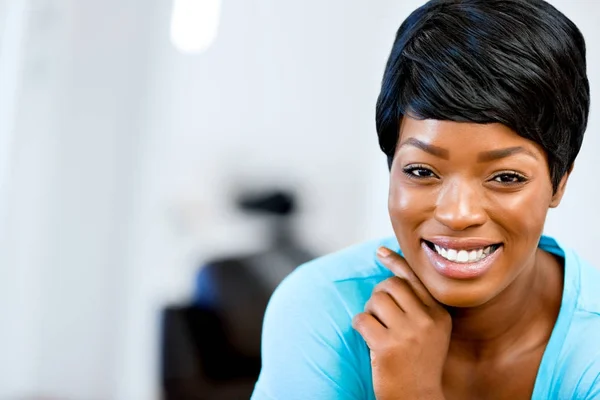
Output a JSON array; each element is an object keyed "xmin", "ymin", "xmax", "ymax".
[{"xmin": 353, "ymin": 116, "xmax": 568, "ymax": 400}]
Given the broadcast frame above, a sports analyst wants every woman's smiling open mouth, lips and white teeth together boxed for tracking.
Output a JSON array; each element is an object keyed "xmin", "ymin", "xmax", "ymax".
[{"xmin": 422, "ymin": 239, "xmax": 504, "ymax": 279}]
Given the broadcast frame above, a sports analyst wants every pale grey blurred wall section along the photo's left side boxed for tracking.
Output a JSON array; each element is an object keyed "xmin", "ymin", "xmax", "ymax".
[{"xmin": 0, "ymin": 0, "xmax": 158, "ymax": 399}]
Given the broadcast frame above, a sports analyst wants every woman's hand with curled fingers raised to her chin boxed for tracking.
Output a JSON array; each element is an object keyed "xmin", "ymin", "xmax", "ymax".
[{"xmin": 352, "ymin": 247, "xmax": 452, "ymax": 400}]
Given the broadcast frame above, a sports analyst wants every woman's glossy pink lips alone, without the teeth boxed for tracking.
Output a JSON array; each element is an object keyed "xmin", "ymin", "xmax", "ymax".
[{"xmin": 421, "ymin": 240, "xmax": 504, "ymax": 279}]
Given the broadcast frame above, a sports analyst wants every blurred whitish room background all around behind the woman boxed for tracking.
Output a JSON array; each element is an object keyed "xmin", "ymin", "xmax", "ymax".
[{"xmin": 0, "ymin": 0, "xmax": 600, "ymax": 400}]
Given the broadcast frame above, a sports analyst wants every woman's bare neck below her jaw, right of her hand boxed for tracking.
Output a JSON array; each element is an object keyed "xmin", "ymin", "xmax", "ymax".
[{"xmin": 449, "ymin": 249, "xmax": 563, "ymax": 361}]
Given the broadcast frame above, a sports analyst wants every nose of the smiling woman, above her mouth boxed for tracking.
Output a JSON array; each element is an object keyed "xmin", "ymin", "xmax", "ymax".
[{"xmin": 435, "ymin": 181, "xmax": 487, "ymax": 231}]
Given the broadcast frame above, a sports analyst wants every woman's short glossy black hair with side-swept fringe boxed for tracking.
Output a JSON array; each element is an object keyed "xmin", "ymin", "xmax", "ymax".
[{"xmin": 376, "ymin": 0, "xmax": 590, "ymax": 191}]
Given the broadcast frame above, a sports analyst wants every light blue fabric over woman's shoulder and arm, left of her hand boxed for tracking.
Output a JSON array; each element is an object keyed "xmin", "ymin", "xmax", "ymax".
[{"xmin": 253, "ymin": 239, "xmax": 398, "ymax": 399}]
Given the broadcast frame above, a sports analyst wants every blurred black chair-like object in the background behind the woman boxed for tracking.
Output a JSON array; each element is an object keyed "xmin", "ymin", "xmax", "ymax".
[{"xmin": 162, "ymin": 191, "xmax": 315, "ymax": 400}]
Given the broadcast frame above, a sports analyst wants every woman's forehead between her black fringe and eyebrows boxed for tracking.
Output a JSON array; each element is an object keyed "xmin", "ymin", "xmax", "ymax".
[{"xmin": 398, "ymin": 116, "xmax": 545, "ymax": 159}]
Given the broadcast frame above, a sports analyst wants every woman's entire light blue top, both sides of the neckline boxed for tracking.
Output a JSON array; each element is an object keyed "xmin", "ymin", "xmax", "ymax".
[{"xmin": 252, "ymin": 236, "xmax": 600, "ymax": 400}]
